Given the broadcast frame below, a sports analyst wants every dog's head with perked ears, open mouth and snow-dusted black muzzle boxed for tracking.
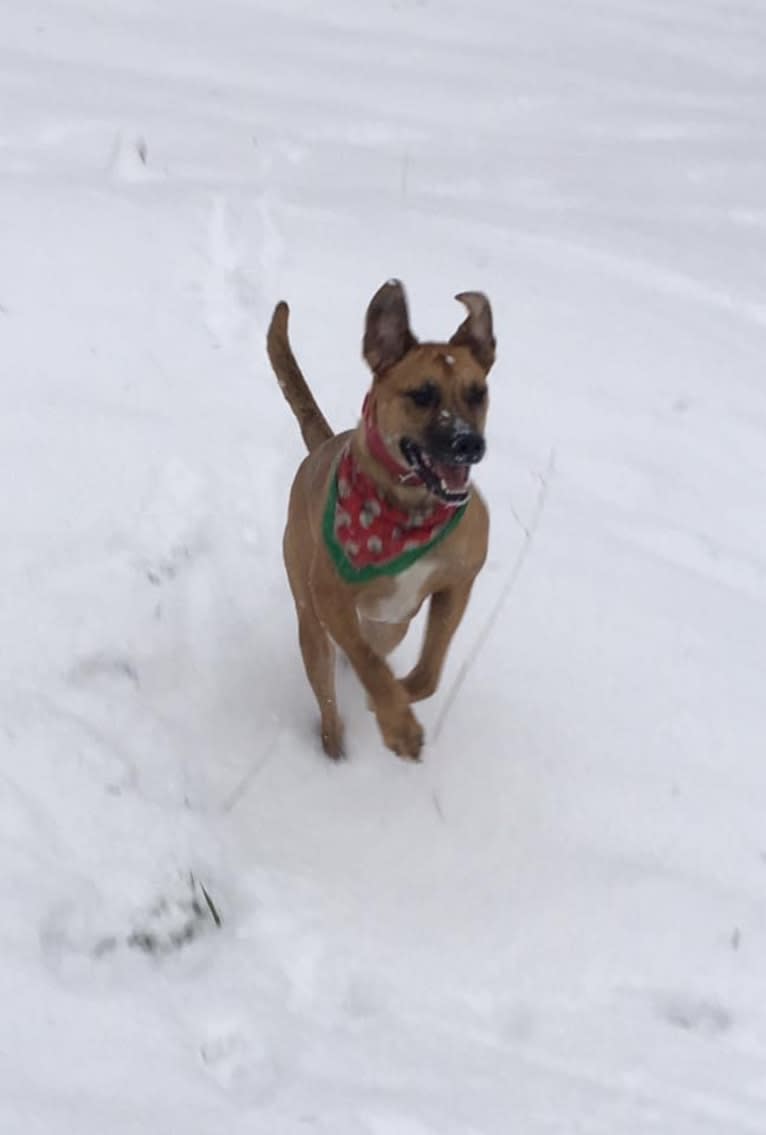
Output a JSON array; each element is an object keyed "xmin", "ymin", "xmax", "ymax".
[{"xmin": 363, "ymin": 280, "xmax": 495, "ymax": 502}]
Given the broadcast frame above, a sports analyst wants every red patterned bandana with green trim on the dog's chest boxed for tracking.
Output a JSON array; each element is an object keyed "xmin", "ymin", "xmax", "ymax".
[{"xmin": 322, "ymin": 444, "xmax": 468, "ymax": 583}]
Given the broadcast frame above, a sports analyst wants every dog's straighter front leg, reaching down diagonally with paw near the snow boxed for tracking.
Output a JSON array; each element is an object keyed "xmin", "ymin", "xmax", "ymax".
[{"xmin": 314, "ymin": 585, "xmax": 423, "ymax": 760}]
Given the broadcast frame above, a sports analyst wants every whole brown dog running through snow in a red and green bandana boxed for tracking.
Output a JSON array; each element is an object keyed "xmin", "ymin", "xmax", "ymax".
[{"xmin": 268, "ymin": 280, "xmax": 495, "ymax": 759}]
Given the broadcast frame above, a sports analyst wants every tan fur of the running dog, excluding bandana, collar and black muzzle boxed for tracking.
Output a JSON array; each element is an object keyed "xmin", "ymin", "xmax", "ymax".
[{"xmin": 268, "ymin": 281, "xmax": 495, "ymax": 759}]
